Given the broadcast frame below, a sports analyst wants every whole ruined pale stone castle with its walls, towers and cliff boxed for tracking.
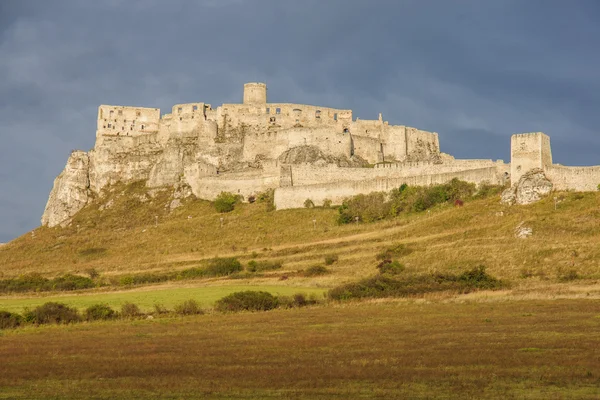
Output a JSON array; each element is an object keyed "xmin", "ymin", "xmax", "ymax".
[{"xmin": 42, "ymin": 83, "xmax": 600, "ymax": 226}]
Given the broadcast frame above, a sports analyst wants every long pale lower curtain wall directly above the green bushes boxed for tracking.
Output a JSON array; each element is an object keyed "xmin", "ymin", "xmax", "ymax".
[{"xmin": 275, "ymin": 167, "xmax": 502, "ymax": 209}]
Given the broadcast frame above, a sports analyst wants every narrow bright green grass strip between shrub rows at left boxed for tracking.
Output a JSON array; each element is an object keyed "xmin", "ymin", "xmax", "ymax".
[{"xmin": 0, "ymin": 285, "xmax": 326, "ymax": 313}]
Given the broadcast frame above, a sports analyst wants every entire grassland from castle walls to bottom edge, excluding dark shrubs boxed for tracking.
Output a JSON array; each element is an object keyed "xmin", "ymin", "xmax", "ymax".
[{"xmin": 0, "ymin": 184, "xmax": 600, "ymax": 399}]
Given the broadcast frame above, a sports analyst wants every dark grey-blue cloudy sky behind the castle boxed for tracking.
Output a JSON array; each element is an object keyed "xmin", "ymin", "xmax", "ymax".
[{"xmin": 0, "ymin": 0, "xmax": 600, "ymax": 242}]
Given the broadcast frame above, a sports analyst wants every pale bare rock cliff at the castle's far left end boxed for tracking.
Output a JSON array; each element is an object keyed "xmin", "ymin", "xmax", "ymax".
[{"xmin": 42, "ymin": 151, "xmax": 90, "ymax": 227}]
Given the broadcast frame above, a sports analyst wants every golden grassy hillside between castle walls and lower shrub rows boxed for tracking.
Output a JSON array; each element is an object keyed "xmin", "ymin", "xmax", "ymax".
[{"xmin": 0, "ymin": 183, "xmax": 600, "ymax": 287}]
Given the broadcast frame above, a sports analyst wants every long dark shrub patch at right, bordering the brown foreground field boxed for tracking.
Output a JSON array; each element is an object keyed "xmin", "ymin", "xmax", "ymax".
[{"xmin": 328, "ymin": 266, "xmax": 506, "ymax": 300}]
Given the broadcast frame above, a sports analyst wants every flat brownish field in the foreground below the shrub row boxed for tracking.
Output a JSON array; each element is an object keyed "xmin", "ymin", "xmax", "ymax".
[{"xmin": 0, "ymin": 299, "xmax": 600, "ymax": 399}]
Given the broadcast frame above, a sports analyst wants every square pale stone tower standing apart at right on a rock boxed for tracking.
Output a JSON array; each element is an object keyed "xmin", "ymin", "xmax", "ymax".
[{"xmin": 510, "ymin": 132, "xmax": 552, "ymax": 185}]
